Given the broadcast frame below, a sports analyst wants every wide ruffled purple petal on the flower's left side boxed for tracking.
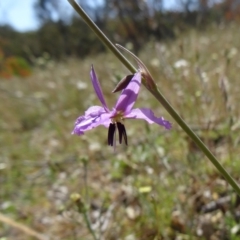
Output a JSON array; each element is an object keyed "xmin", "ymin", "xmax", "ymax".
[{"xmin": 72, "ymin": 106, "xmax": 111, "ymax": 135}]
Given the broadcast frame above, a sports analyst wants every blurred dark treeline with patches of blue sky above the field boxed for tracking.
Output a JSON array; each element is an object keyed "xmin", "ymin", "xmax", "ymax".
[{"xmin": 0, "ymin": 0, "xmax": 239, "ymax": 68}]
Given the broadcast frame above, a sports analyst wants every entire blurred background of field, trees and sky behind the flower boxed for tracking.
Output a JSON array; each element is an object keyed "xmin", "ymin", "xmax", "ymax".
[{"xmin": 0, "ymin": 0, "xmax": 240, "ymax": 240}]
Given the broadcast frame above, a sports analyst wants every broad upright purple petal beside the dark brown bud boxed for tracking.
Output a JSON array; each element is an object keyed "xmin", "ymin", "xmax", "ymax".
[{"xmin": 115, "ymin": 72, "xmax": 141, "ymax": 114}]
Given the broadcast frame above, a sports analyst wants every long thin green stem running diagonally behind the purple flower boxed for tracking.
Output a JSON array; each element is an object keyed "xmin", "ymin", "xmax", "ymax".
[{"xmin": 68, "ymin": 0, "xmax": 240, "ymax": 196}]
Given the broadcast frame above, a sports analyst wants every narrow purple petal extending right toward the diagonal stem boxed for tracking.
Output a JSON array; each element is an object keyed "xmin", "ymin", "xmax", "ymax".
[{"xmin": 125, "ymin": 108, "xmax": 172, "ymax": 129}]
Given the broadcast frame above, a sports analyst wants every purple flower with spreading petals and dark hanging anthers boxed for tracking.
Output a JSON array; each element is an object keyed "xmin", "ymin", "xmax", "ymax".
[{"xmin": 72, "ymin": 66, "xmax": 171, "ymax": 146}]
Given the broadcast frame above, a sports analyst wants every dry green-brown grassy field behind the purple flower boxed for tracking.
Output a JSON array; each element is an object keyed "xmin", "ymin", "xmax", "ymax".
[{"xmin": 0, "ymin": 24, "xmax": 240, "ymax": 240}]
